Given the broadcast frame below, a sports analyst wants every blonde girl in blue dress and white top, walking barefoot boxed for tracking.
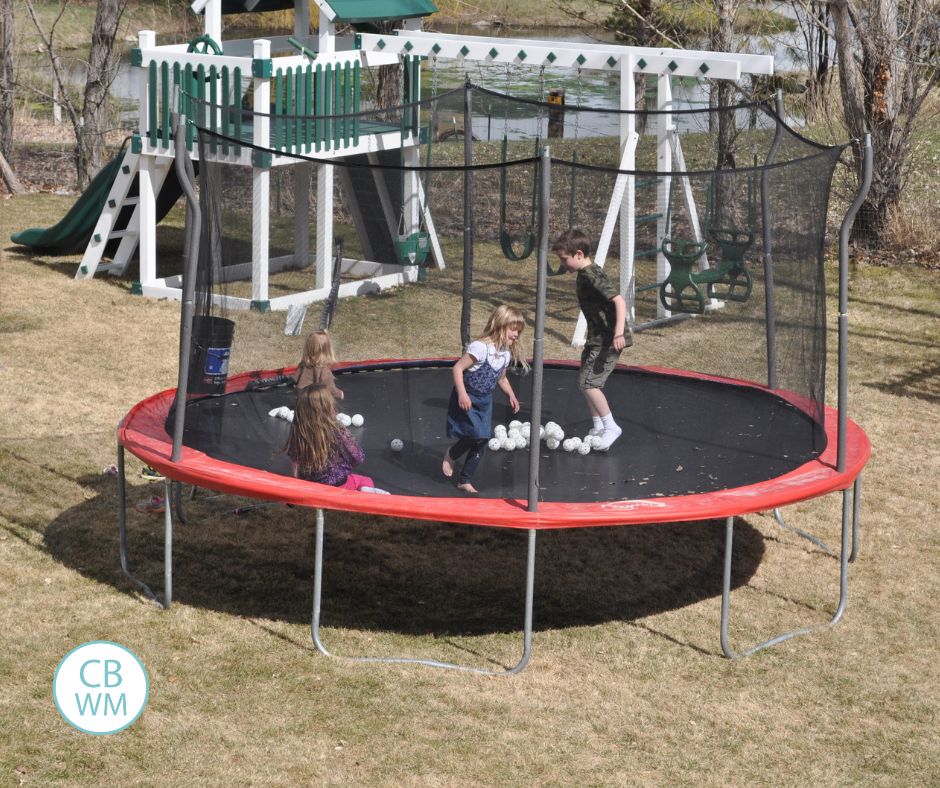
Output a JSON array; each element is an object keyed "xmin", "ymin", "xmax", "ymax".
[{"xmin": 441, "ymin": 305, "xmax": 528, "ymax": 495}]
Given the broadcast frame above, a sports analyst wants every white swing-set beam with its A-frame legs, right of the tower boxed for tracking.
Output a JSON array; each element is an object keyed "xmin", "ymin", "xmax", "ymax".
[{"xmin": 357, "ymin": 30, "xmax": 774, "ymax": 346}]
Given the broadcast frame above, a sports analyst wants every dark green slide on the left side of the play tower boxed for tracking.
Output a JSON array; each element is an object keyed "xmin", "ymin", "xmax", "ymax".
[{"xmin": 10, "ymin": 148, "xmax": 182, "ymax": 257}]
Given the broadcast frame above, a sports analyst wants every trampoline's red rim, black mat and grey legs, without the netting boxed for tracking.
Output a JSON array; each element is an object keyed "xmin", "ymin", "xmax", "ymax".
[{"xmin": 118, "ymin": 359, "xmax": 870, "ymax": 673}]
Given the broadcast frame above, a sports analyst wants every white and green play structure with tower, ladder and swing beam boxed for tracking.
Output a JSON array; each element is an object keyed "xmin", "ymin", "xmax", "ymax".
[{"xmin": 66, "ymin": 0, "xmax": 773, "ymax": 330}]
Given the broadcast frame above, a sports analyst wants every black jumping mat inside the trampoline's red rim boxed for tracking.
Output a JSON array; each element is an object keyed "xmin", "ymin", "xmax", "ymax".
[{"xmin": 174, "ymin": 362, "xmax": 826, "ymax": 503}]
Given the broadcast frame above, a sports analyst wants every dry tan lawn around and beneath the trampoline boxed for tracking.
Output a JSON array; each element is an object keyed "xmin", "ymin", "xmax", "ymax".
[{"xmin": 0, "ymin": 166, "xmax": 940, "ymax": 786}]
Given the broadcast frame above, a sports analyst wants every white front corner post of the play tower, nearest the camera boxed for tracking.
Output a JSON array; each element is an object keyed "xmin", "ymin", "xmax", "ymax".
[{"xmin": 251, "ymin": 39, "xmax": 271, "ymax": 304}]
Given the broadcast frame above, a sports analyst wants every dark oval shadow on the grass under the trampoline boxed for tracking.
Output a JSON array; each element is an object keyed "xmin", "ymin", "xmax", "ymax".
[{"xmin": 45, "ymin": 470, "xmax": 764, "ymax": 636}]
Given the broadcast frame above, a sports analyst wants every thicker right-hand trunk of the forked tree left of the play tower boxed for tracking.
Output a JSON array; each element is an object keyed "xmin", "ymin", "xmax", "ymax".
[{"xmin": 77, "ymin": 0, "xmax": 126, "ymax": 188}]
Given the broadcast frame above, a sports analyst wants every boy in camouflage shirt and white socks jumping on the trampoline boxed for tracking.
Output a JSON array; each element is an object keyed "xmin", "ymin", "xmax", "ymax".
[{"xmin": 552, "ymin": 228, "xmax": 633, "ymax": 451}]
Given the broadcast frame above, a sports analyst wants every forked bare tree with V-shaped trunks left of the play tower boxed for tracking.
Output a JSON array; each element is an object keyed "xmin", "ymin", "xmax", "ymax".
[{"xmin": 25, "ymin": 0, "xmax": 127, "ymax": 188}]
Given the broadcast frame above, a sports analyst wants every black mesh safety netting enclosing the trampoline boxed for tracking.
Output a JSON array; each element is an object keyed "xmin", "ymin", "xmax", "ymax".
[{"xmin": 180, "ymin": 80, "xmax": 842, "ymax": 492}]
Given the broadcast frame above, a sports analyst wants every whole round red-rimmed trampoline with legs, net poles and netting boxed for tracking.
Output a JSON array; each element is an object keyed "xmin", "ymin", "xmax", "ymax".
[{"xmin": 118, "ymin": 82, "xmax": 871, "ymax": 674}]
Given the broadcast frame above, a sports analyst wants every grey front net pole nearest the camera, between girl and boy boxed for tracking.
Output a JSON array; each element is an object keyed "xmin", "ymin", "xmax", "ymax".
[{"xmin": 529, "ymin": 146, "xmax": 552, "ymax": 512}]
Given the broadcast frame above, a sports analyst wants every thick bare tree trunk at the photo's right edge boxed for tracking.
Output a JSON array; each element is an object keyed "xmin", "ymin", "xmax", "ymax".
[{"xmin": 829, "ymin": 0, "xmax": 940, "ymax": 243}]
